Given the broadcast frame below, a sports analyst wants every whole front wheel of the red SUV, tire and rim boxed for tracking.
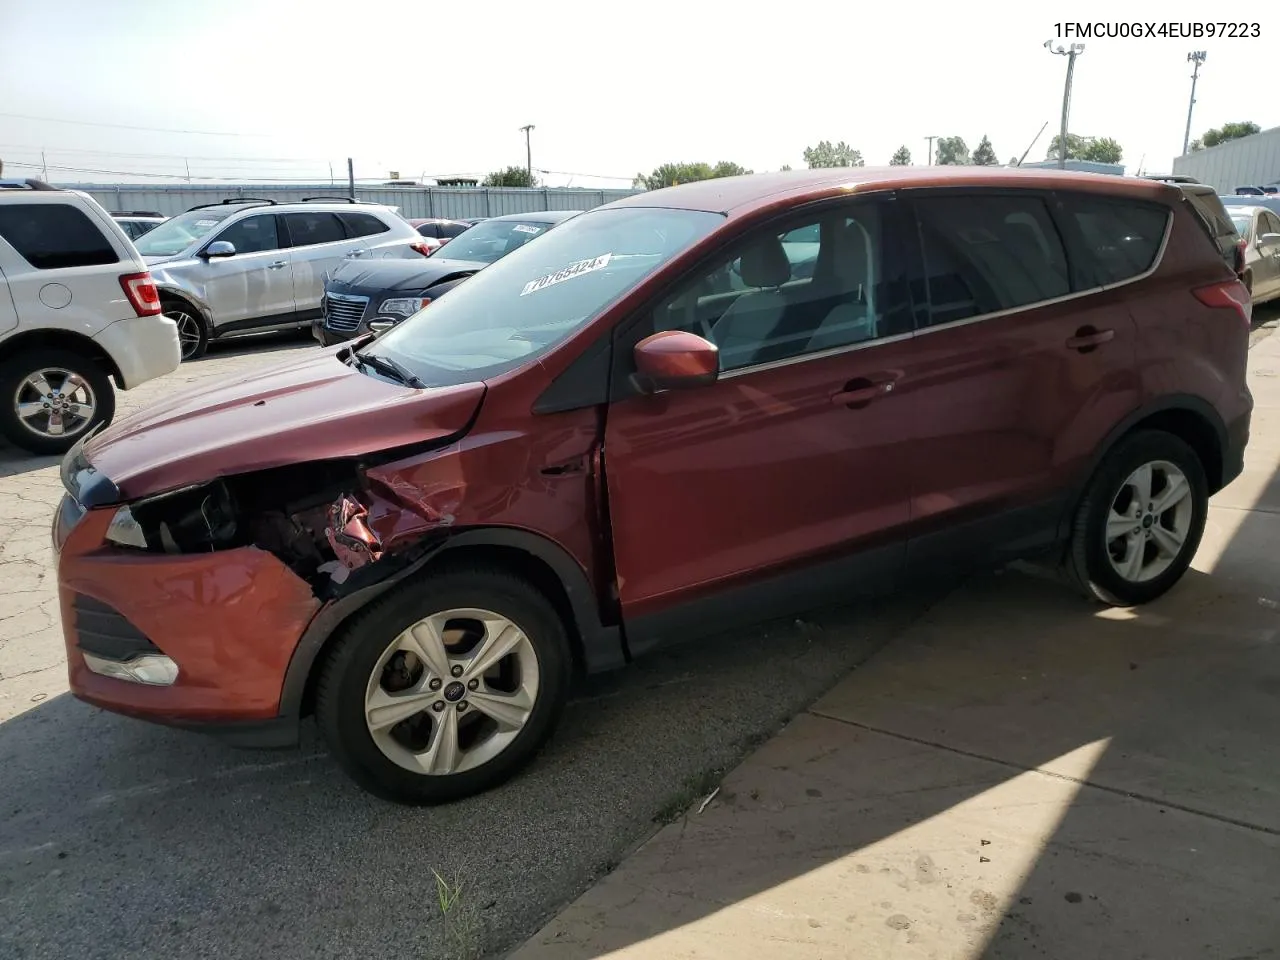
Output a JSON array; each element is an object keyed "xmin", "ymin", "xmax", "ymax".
[{"xmin": 316, "ymin": 567, "xmax": 571, "ymax": 804}]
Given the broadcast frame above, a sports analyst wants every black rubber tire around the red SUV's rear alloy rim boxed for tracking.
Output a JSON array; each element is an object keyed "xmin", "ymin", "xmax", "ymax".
[{"xmin": 1065, "ymin": 430, "xmax": 1208, "ymax": 607}]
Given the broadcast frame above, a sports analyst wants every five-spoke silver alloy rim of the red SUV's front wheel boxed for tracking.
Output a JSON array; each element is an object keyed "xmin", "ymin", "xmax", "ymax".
[{"xmin": 365, "ymin": 609, "xmax": 540, "ymax": 776}]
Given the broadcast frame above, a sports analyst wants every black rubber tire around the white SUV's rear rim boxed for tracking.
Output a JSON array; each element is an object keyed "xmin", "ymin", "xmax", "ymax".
[{"xmin": 0, "ymin": 347, "xmax": 115, "ymax": 456}]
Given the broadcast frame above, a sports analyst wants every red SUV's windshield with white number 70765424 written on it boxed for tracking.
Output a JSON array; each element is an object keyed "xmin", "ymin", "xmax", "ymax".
[{"xmin": 367, "ymin": 207, "xmax": 724, "ymax": 387}]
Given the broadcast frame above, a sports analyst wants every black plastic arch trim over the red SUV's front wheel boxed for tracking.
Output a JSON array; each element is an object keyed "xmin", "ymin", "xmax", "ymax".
[{"xmin": 279, "ymin": 527, "xmax": 628, "ymax": 719}]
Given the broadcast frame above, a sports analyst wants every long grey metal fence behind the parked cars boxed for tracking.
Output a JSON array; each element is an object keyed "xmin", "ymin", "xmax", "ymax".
[{"xmin": 61, "ymin": 183, "xmax": 643, "ymax": 219}]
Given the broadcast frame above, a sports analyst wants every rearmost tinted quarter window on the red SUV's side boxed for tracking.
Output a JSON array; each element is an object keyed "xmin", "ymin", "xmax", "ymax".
[{"xmin": 1064, "ymin": 196, "xmax": 1172, "ymax": 284}]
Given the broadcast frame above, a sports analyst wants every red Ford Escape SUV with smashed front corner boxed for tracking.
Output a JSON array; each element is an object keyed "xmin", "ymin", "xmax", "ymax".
[{"xmin": 54, "ymin": 166, "xmax": 1253, "ymax": 803}]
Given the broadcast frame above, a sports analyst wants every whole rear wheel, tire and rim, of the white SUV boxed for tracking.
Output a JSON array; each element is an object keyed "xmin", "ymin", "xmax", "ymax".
[{"xmin": 0, "ymin": 347, "xmax": 115, "ymax": 454}]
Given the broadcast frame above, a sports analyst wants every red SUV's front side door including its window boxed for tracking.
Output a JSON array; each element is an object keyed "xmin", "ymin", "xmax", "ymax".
[{"xmin": 604, "ymin": 201, "xmax": 913, "ymax": 654}]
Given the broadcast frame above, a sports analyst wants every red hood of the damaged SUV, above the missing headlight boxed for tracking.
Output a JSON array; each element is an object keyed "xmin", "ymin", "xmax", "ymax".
[{"xmin": 83, "ymin": 344, "xmax": 485, "ymax": 499}]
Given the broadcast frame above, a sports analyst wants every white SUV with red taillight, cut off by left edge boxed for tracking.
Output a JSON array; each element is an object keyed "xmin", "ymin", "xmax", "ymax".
[{"xmin": 0, "ymin": 180, "xmax": 180, "ymax": 453}]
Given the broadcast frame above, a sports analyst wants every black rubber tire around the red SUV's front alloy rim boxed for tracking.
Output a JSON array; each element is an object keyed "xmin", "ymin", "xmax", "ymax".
[{"xmin": 316, "ymin": 566, "xmax": 572, "ymax": 805}]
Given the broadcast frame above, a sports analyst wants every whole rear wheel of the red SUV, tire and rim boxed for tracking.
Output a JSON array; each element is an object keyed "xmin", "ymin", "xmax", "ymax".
[{"xmin": 1066, "ymin": 430, "xmax": 1208, "ymax": 607}]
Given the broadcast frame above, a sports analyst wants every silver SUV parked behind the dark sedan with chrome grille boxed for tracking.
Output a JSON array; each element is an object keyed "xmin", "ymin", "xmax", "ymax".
[{"xmin": 137, "ymin": 197, "xmax": 431, "ymax": 360}]
